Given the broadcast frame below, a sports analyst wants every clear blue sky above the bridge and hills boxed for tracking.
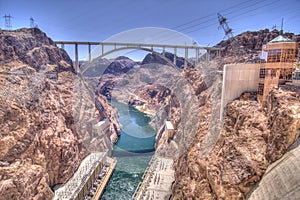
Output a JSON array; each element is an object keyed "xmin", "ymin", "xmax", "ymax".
[{"xmin": 0, "ymin": 0, "xmax": 300, "ymax": 59}]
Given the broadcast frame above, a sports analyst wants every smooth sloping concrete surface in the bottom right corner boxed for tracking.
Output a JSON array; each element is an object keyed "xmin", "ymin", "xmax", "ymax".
[{"xmin": 248, "ymin": 145, "xmax": 300, "ymax": 200}]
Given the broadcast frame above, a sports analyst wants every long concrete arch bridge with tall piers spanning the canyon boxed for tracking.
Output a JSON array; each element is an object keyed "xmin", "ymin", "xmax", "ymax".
[{"xmin": 54, "ymin": 41, "xmax": 222, "ymax": 71}]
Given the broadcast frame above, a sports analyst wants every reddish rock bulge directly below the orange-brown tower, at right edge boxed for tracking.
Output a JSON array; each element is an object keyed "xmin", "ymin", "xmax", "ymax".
[{"xmin": 267, "ymin": 86, "xmax": 300, "ymax": 162}]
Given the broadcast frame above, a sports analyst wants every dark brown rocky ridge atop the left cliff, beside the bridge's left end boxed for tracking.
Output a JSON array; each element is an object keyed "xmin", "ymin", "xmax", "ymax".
[{"xmin": 0, "ymin": 28, "xmax": 74, "ymax": 72}]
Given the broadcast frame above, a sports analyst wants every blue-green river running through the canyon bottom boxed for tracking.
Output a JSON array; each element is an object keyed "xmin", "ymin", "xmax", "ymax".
[{"xmin": 101, "ymin": 101, "xmax": 155, "ymax": 200}]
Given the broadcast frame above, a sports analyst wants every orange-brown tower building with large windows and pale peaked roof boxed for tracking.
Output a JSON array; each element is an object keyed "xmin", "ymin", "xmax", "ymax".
[{"xmin": 257, "ymin": 35, "xmax": 298, "ymax": 105}]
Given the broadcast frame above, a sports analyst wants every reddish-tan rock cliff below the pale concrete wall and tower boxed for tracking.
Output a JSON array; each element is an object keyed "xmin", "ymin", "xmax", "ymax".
[{"xmin": 172, "ymin": 88, "xmax": 300, "ymax": 199}]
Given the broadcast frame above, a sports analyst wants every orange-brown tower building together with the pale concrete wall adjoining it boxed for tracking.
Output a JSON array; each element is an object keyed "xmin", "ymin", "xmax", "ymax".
[{"xmin": 220, "ymin": 34, "xmax": 300, "ymax": 119}]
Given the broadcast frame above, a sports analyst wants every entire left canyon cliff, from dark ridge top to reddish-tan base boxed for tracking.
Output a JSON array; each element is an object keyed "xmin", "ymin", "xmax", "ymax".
[{"xmin": 0, "ymin": 28, "xmax": 117, "ymax": 199}]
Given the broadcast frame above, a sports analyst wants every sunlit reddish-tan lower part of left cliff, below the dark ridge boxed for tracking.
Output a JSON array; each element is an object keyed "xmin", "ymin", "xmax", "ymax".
[{"xmin": 0, "ymin": 67, "xmax": 88, "ymax": 199}]
